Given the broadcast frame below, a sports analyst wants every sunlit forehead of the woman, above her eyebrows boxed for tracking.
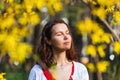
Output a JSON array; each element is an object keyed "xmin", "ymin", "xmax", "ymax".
[{"xmin": 52, "ymin": 23, "xmax": 68, "ymax": 32}]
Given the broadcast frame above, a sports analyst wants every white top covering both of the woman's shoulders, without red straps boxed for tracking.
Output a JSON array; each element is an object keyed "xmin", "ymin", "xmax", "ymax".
[{"xmin": 28, "ymin": 61, "xmax": 89, "ymax": 80}]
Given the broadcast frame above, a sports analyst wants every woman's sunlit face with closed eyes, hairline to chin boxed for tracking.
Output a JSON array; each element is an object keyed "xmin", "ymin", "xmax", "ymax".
[{"xmin": 50, "ymin": 23, "xmax": 72, "ymax": 51}]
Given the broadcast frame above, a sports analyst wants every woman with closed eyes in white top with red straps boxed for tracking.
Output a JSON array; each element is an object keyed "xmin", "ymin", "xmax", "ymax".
[{"xmin": 28, "ymin": 19, "xmax": 89, "ymax": 80}]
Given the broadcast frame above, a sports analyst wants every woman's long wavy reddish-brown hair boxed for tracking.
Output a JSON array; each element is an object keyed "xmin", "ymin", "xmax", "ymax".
[{"xmin": 38, "ymin": 19, "xmax": 77, "ymax": 67}]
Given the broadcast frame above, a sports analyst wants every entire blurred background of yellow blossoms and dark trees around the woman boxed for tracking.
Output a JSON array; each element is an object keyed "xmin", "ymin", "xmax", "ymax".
[{"xmin": 0, "ymin": 0, "xmax": 120, "ymax": 80}]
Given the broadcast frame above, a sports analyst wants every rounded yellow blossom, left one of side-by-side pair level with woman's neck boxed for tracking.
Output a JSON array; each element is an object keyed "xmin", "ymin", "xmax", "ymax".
[{"xmin": 86, "ymin": 45, "xmax": 97, "ymax": 57}]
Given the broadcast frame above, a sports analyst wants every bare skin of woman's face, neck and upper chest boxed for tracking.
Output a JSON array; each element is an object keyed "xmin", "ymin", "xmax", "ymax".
[{"xmin": 48, "ymin": 23, "xmax": 72, "ymax": 80}]
